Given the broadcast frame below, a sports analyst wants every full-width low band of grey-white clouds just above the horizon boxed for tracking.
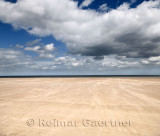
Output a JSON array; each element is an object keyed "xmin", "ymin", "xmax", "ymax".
[{"xmin": 0, "ymin": 49, "xmax": 160, "ymax": 74}]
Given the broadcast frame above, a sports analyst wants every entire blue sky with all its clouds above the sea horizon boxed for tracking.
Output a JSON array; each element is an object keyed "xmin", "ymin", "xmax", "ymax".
[{"xmin": 0, "ymin": 0, "xmax": 160, "ymax": 76}]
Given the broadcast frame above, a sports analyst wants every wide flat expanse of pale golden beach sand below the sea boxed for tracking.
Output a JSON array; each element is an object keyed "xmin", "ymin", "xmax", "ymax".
[{"xmin": 0, "ymin": 77, "xmax": 160, "ymax": 136}]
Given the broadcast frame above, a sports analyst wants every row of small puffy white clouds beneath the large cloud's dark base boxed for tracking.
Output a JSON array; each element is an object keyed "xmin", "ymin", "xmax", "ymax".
[{"xmin": 53, "ymin": 55, "xmax": 160, "ymax": 71}]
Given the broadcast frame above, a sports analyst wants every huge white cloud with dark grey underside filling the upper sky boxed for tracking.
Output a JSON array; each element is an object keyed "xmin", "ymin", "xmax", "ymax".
[{"xmin": 0, "ymin": 0, "xmax": 160, "ymax": 58}]
